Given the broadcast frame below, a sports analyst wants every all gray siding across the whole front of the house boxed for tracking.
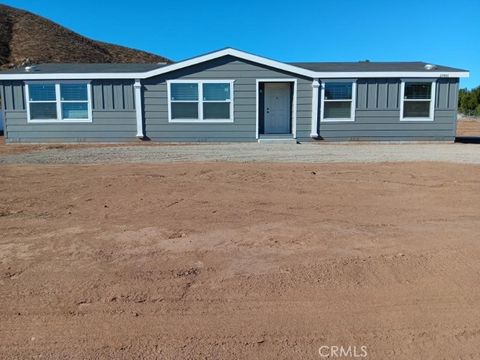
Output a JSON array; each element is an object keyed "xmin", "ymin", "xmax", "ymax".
[{"xmin": 0, "ymin": 56, "xmax": 459, "ymax": 142}]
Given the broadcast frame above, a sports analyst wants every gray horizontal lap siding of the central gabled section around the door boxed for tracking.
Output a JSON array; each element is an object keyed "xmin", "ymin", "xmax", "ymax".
[{"xmin": 142, "ymin": 56, "xmax": 312, "ymax": 142}]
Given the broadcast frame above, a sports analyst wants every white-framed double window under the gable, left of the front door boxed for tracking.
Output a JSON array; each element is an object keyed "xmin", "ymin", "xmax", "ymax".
[{"xmin": 167, "ymin": 80, "xmax": 234, "ymax": 123}]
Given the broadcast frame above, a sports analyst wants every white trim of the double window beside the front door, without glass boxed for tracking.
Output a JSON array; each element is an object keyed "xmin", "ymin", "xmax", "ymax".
[{"xmin": 167, "ymin": 79, "xmax": 235, "ymax": 124}]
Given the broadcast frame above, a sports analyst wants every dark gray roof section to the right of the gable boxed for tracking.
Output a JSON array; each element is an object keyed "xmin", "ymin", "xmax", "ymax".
[{"xmin": 289, "ymin": 61, "xmax": 467, "ymax": 72}]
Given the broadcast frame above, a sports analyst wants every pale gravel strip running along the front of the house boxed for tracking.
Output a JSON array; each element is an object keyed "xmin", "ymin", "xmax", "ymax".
[{"xmin": 0, "ymin": 143, "xmax": 480, "ymax": 164}]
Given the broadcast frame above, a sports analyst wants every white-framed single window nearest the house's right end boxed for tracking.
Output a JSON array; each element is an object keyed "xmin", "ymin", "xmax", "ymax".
[{"xmin": 400, "ymin": 80, "xmax": 436, "ymax": 121}]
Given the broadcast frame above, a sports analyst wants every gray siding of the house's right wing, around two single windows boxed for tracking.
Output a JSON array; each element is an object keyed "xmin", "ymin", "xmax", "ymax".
[{"xmin": 318, "ymin": 78, "xmax": 459, "ymax": 141}]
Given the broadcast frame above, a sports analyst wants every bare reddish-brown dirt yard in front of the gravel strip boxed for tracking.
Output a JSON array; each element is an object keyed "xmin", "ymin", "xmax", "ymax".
[{"xmin": 0, "ymin": 162, "xmax": 480, "ymax": 359}]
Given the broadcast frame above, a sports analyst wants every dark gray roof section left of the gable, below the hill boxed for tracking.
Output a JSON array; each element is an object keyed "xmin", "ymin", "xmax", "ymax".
[{"xmin": 3, "ymin": 63, "xmax": 168, "ymax": 74}]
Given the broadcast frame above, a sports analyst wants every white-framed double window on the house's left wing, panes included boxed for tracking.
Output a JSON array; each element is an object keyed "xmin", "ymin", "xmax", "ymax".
[{"xmin": 25, "ymin": 81, "xmax": 92, "ymax": 123}]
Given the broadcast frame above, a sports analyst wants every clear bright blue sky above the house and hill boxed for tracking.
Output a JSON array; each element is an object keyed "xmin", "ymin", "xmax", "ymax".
[{"xmin": 3, "ymin": 0, "xmax": 480, "ymax": 88}]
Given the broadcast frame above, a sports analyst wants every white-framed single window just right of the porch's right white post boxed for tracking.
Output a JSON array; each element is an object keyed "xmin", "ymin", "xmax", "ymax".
[{"xmin": 320, "ymin": 80, "xmax": 357, "ymax": 122}]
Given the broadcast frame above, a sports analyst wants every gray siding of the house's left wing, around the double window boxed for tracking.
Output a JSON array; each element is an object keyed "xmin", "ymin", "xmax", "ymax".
[{"xmin": 0, "ymin": 80, "xmax": 136, "ymax": 142}]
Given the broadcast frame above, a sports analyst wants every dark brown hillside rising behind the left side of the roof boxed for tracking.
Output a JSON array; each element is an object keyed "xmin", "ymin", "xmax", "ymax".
[{"xmin": 0, "ymin": 4, "xmax": 170, "ymax": 68}]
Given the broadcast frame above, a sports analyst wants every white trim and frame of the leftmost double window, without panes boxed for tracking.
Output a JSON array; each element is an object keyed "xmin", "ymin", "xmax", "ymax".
[{"xmin": 25, "ymin": 80, "xmax": 93, "ymax": 124}]
